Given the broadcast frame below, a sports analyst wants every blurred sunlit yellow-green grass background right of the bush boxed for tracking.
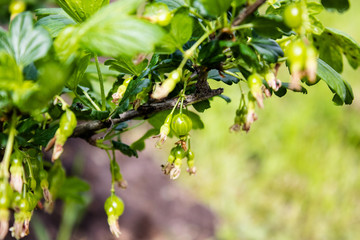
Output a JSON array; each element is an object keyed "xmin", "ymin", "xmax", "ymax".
[{"xmin": 163, "ymin": 0, "xmax": 360, "ymax": 240}]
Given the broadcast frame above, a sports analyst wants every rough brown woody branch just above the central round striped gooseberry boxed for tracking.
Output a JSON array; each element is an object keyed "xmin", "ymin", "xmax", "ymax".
[{"xmin": 72, "ymin": 88, "xmax": 224, "ymax": 139}]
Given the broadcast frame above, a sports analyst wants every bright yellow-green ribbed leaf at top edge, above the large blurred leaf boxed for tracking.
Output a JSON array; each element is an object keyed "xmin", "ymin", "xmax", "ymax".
[{"xmin": 56, "ymin": 0, "xmax": 109, "ymax": 23}]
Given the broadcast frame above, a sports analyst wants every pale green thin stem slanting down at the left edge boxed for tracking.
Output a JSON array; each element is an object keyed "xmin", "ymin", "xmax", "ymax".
[{"xmin": 1, "ymin": 111, "xmax": 17, "ymax": 182}]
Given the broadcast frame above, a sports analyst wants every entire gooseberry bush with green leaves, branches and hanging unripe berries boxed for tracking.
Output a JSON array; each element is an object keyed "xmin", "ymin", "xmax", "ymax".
[{"xmin": 0, "ymin": 0, "xmax": 360, "ymax": 239}]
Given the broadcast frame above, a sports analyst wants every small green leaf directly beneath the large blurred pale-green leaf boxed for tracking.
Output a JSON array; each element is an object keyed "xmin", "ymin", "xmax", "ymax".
[{"xmin": 105, "ymin": 57, "xmax": 148, "ymax": 76}]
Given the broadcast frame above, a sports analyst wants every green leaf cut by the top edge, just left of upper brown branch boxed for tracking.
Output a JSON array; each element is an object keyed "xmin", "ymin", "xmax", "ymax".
[{"xmin": 193, "ymin": 0, "xmax": 232, "ymax": 18}]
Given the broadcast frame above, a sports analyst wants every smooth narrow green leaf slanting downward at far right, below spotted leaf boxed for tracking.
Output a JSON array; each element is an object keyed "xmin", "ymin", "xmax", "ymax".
[{"xmin": 317, "ymin": 59, "xmax": 354, "ymax": 104}]
